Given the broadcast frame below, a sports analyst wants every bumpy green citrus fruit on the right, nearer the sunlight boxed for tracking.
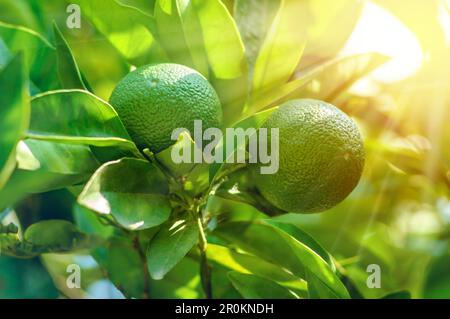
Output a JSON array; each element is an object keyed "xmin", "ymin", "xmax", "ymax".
[{"xmin": 254, "ymin": 99, "xmax": 365, "ymax": 213}]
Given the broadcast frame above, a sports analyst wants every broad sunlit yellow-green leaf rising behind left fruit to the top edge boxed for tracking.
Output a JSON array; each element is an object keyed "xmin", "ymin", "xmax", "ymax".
[{"xmin": 155, "ymin": 0, "xmax": 247, "ymax": 123}]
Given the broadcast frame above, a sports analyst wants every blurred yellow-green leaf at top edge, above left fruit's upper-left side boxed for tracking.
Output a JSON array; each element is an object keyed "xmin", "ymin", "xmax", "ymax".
[{"xmin": 80, "ymin": 0, "xmax": 161, "ymax": 65}]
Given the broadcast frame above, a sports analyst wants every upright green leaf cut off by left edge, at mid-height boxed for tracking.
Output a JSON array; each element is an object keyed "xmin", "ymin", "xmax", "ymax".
[{"xmin": 0, "ymin": 55, "xmax": 30, "ymax": 189}]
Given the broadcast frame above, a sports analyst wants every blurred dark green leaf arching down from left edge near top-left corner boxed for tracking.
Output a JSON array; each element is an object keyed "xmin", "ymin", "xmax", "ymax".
[{"xmin": 0, "ymin": 21, "xmax": 60, "ymax": 91}]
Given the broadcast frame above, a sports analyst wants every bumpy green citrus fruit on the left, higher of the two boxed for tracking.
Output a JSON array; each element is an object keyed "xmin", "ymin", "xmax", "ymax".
[{"xmin": 110, "ymin": 63, "xmax": 222, "ymax": 153}]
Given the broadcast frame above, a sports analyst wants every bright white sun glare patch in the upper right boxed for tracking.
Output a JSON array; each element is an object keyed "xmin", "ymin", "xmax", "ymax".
[{"xmin": 342, "ymin": 1, "xmax": 424, "ymax": 83}]
